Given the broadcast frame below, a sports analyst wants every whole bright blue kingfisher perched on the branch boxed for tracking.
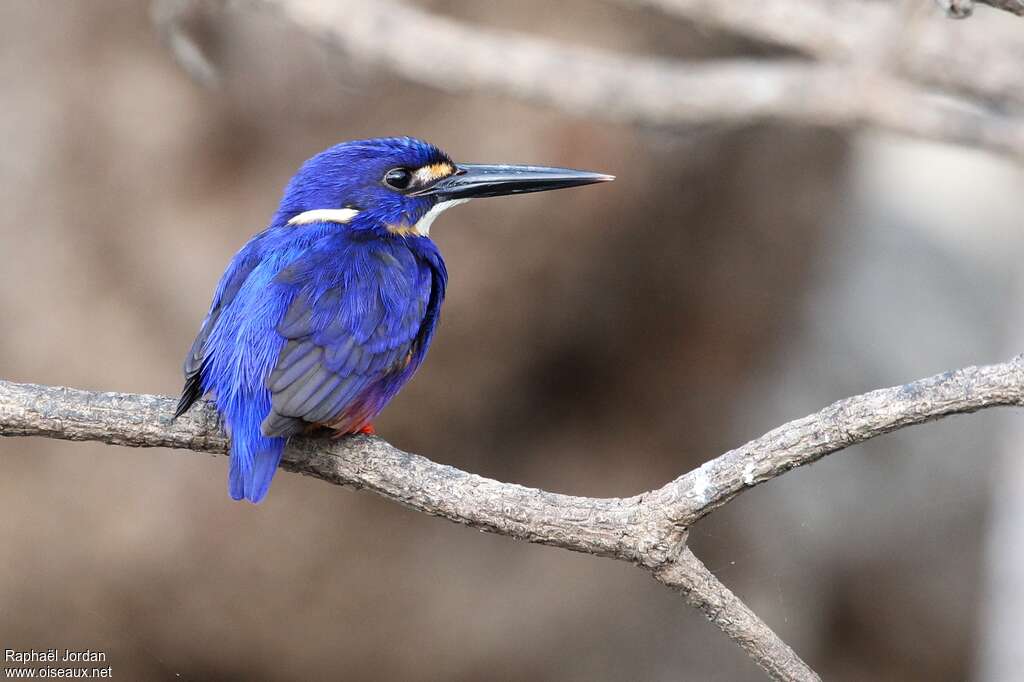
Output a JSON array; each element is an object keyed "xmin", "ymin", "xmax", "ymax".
[{"xmin": 174, "ymin": 137, "xmax": 614, "ymax": 504}]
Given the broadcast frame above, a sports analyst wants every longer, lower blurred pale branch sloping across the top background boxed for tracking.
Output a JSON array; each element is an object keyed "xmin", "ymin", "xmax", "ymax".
[{"xmin": 245, "ymin": 0, "xmax": 1024, "ymax": 157}]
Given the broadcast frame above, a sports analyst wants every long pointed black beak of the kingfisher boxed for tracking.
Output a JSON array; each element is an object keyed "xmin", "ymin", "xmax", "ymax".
[{"xmin": 414, "ymin": 164, "xmax": 615, "ymax": 201}]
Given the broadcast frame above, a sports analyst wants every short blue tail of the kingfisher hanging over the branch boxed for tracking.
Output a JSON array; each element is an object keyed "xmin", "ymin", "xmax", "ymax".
[{"xmin": 227, "ymin": 395, "xmax": 287, "ymax": 504}]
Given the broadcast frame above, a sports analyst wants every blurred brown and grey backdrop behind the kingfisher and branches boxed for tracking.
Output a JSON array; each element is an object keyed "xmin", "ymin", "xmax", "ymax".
[{"xmin": 0, "ymin": 0, "xmax": 1022, "ymax": 681}]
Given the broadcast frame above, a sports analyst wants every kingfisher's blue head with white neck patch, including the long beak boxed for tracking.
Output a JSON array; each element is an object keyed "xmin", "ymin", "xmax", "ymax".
[{"xmin": 272, "ymin": 137, "xmax": 613, "ymax": 237}]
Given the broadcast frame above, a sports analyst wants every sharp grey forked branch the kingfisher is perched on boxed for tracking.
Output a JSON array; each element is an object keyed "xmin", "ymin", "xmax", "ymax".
[{"xmin": 0, "ymin": 356, "xmax": 1024, "ymax": 680}]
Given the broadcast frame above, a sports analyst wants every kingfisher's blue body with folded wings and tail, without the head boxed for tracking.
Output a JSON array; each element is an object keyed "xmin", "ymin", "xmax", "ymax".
[{"xmin": 178, "ymin": 228, "xmax": 446, "ymax": 502}]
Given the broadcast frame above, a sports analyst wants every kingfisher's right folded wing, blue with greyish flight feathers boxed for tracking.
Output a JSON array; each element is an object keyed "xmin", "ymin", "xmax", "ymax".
[{"xmin": 261, "ymin": 236, "xmax": 439, "ymax": 437}]
